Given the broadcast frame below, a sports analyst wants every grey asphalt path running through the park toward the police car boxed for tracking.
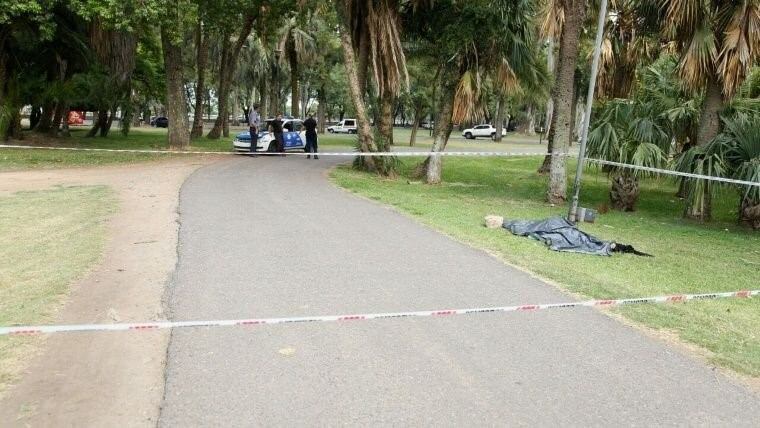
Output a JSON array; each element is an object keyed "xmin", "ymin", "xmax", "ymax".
[{"xmin": 160, "ymin": 157, "xmax": 760, "ymax": 427}]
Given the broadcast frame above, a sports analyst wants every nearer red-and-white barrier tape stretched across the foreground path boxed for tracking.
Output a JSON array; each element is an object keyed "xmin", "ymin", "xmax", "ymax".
[{"xmin": 0, "ymin": 290, "xmax": 760, "ymax": 336}]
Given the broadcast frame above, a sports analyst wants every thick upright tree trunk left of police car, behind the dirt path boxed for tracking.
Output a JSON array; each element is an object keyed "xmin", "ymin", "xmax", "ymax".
[{"xmin": 161, "ymin": 25, "xmax": 190, "ymax": 150}]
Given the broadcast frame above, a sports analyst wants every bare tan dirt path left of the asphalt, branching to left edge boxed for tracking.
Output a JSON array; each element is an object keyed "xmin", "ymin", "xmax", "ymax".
[{"xmin": 0, "ymin": 156, "xmax": 219, "ymax": 426}]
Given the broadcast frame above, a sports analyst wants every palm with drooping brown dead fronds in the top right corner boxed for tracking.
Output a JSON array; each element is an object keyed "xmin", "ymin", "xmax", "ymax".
[{"xmin": 664, "ymin": 0, "xmax": 760, "ymax": 220}]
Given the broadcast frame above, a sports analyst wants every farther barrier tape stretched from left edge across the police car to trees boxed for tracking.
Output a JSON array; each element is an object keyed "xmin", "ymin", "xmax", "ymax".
[{"xmin": 0, "ymin": 144, "xmax": 548, "ymax": 157}]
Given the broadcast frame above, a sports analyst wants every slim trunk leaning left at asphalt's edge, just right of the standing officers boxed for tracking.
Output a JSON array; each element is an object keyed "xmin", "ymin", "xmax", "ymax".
[{"xmin": 340, "ymin": 25, "xmax": 383, "ymax": 174}]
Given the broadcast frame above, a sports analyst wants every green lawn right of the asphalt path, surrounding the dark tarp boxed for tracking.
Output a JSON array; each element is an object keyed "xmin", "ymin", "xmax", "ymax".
[{"xmin": 332, "ymin": 158, "xmax": 760, "ymax": 376}]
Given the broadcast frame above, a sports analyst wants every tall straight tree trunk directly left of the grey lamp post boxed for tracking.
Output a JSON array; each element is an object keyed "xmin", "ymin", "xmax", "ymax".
[{"xmin": 547, "ymin": 0, "xmax": 586, "ymax": 204}]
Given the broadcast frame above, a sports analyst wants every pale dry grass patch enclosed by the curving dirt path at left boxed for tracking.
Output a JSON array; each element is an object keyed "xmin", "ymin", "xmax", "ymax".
[{"xmin": 0, "ymin": 186, "xmax": 117, "ymax": 391}]
